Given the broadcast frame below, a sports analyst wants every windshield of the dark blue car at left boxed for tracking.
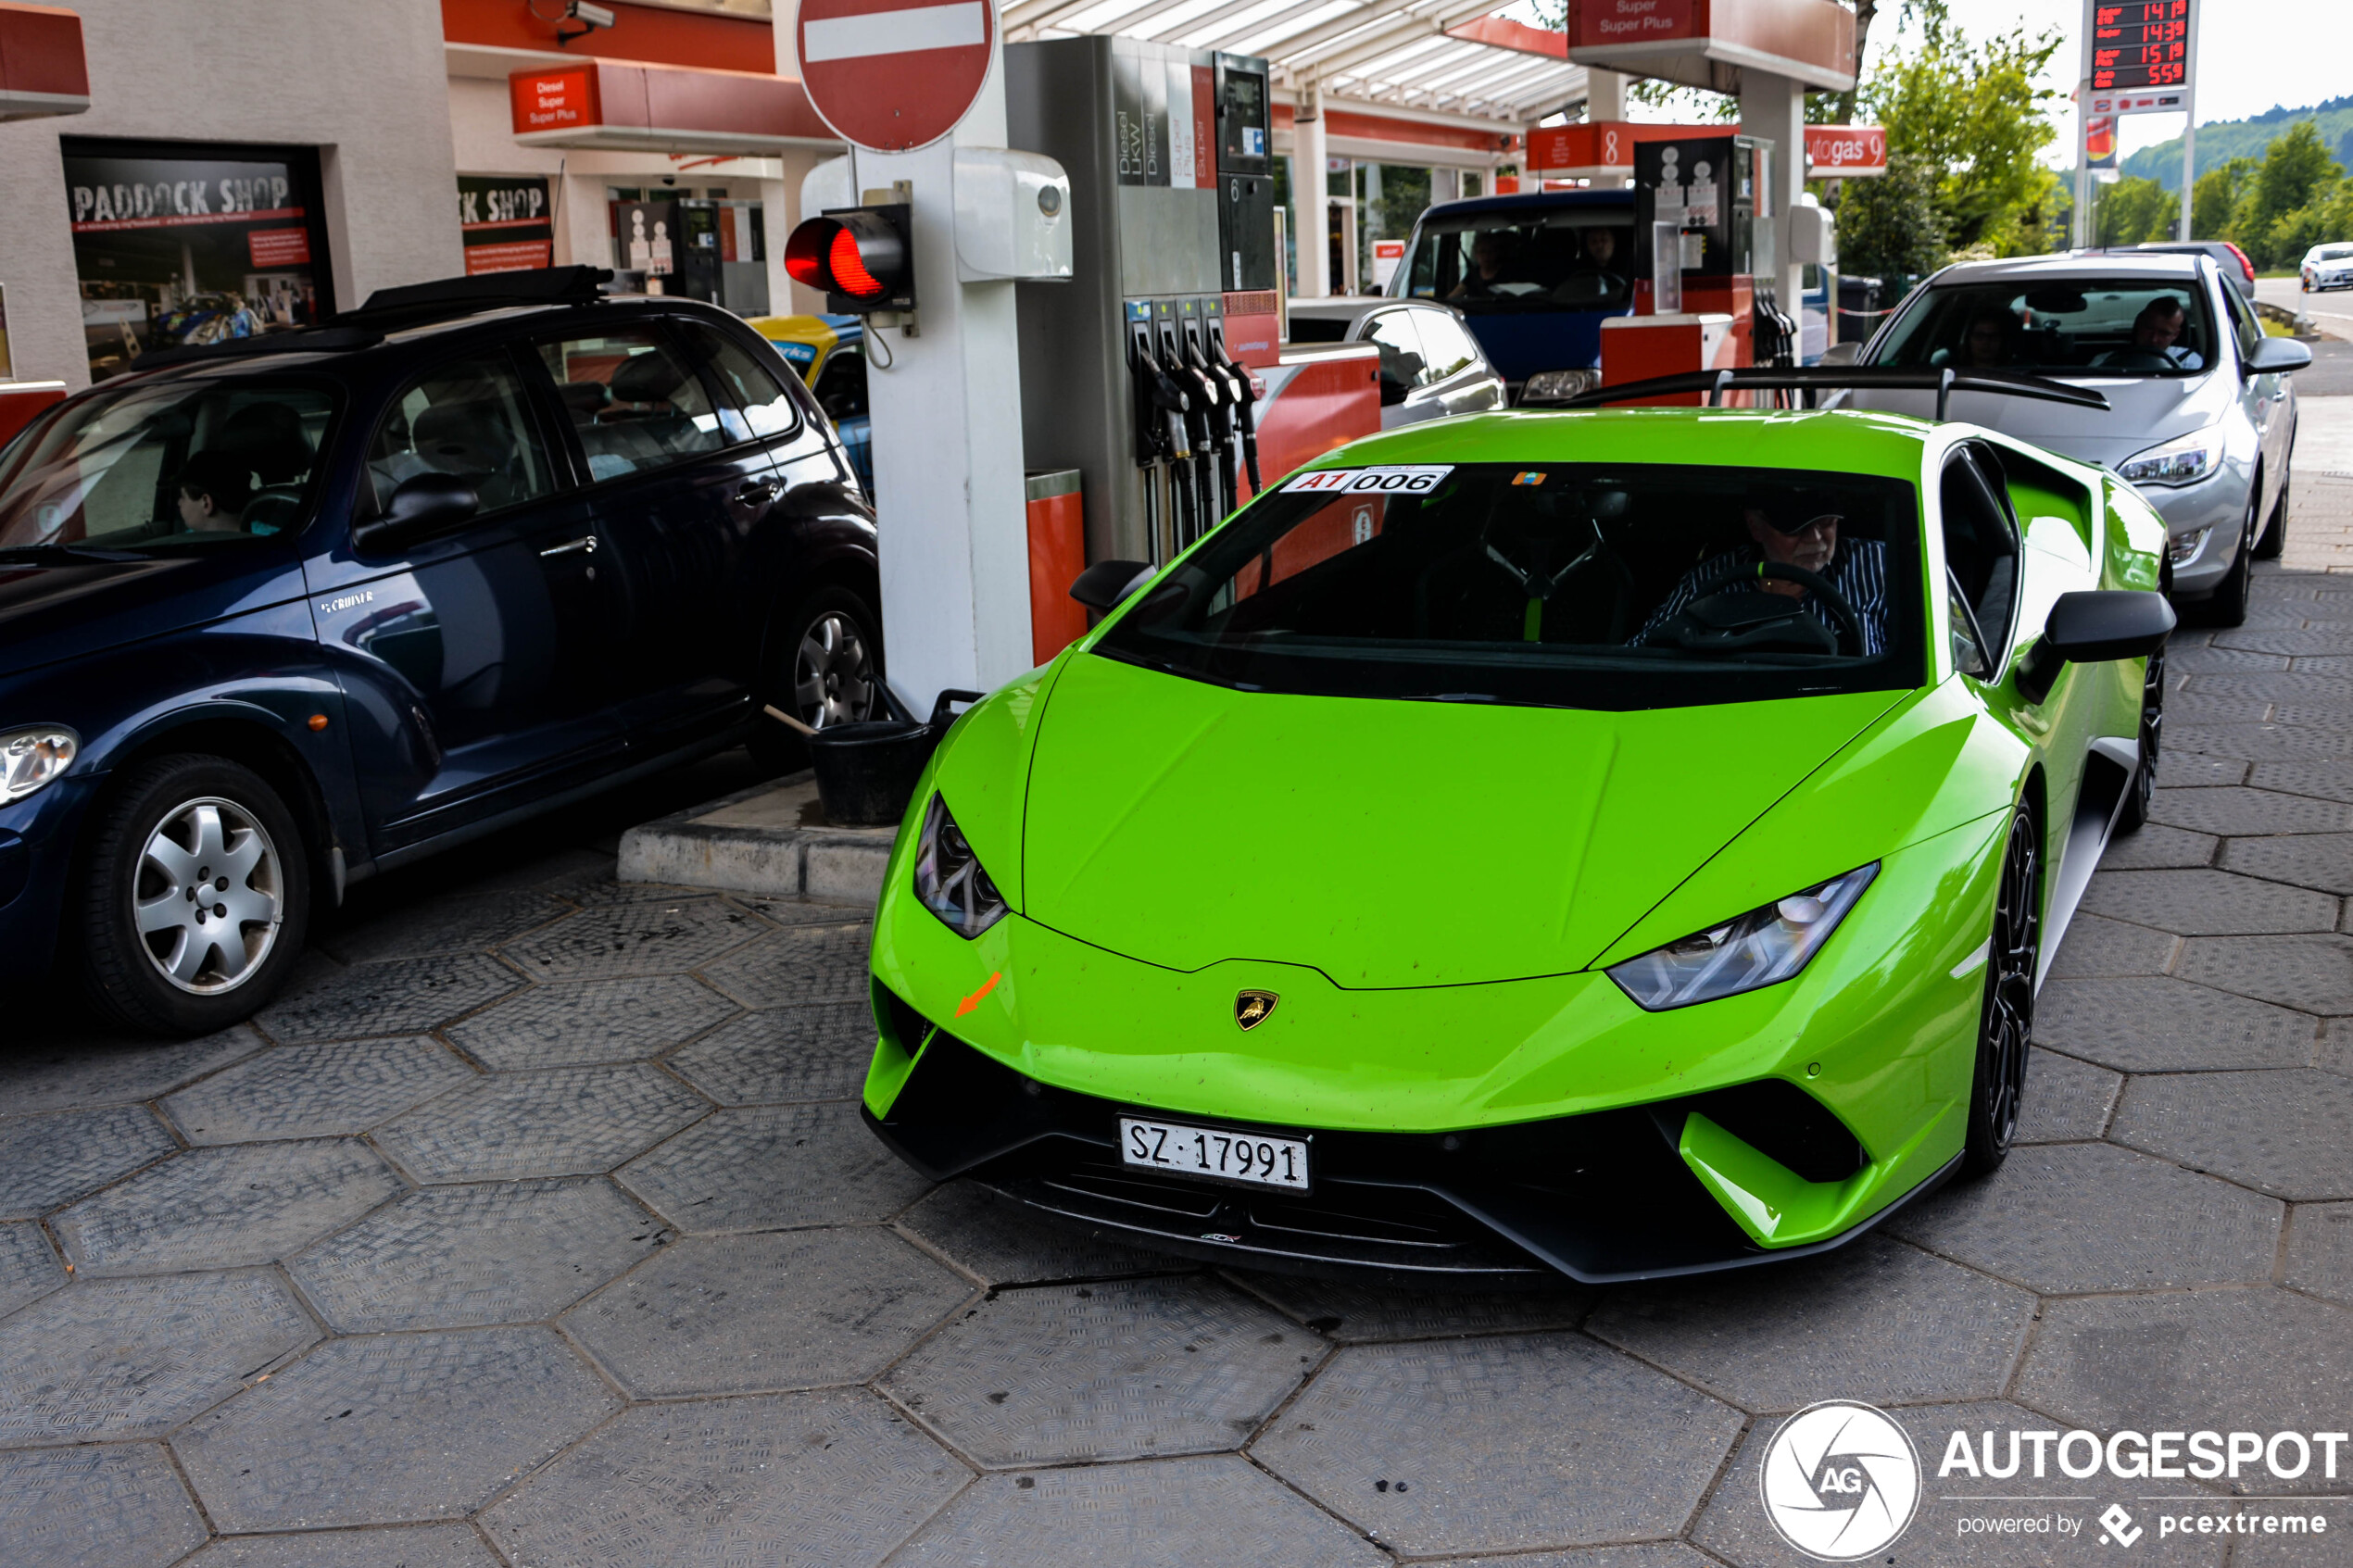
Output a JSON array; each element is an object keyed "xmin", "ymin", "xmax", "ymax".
[{"xmin": 0, "ymin": 379, "xmax": 334, "ymax": 550}]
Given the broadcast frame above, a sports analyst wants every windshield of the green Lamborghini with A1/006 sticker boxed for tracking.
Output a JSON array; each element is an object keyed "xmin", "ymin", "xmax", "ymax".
[{"xmin": 1097, "ymin": 463, "xmax": 1925, "ymax": 710}]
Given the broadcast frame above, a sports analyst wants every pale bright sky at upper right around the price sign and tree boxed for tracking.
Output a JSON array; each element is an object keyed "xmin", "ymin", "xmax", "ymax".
[{"xmin": 1870, "ymin": 0, "xmax": 2353, "ymax": 165}]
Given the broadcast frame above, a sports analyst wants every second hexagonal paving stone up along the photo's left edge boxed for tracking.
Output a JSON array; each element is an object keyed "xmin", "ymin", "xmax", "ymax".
[{"xmin": 0, "ymin": 1270, "xmax": 320, "ymax": 1449}]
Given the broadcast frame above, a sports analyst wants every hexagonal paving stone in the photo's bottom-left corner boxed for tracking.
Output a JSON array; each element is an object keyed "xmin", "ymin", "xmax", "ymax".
[{"xmin": 0, "ymin": 1443, "xmax": 205, "ymax": 1568}]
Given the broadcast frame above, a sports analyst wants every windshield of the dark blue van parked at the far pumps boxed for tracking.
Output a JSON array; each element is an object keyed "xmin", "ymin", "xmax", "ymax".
[{"xmin": 1404, "ymin": 207, "xmax": 1633, "ymax": 315}]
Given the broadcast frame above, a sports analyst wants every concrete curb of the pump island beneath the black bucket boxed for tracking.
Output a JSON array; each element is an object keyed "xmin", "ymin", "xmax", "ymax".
[{"xmin": 619, "ymin": 773, "xmax": 897, "ymax": 909}]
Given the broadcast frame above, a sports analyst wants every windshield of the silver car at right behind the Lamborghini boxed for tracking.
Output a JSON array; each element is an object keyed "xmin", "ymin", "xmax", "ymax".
[{"xmin": 1866, "ymin": 278, "xmax": 2214, "ymax": 376}]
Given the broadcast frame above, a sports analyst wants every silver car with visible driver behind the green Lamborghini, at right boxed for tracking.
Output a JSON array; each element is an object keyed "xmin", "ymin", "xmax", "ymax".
[{"xmin": 1844, "ymin": 252, "xmax": 2313, "ymax": 625}]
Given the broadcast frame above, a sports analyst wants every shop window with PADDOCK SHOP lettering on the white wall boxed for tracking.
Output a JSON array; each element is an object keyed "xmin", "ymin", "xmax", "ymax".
[{"xmin": 59, "ymin": 136, "xmax": 334, "ymax": 381}]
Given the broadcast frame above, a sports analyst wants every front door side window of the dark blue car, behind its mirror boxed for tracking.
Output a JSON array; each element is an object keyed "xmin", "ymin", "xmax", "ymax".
[{"xmin": 367, "ymin": 353, "xmax": 555, "ymax": 512}]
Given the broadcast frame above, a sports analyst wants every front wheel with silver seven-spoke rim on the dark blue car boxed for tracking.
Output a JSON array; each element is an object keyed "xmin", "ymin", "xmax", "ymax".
[{"xmin": 69, "ymin": 755, "xmax": 310, "ymax": 1036}]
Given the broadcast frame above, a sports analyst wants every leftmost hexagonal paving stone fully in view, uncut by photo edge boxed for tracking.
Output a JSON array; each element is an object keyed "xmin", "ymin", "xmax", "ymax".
[{"xmin": 52, "ymin": 1138, "xmax": 400, "ymax": 1274}]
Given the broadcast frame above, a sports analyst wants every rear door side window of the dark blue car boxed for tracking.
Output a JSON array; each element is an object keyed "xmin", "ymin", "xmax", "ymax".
[{"xmin": 539, "ymin": 327, "xmax": 727, "ymax": 480}]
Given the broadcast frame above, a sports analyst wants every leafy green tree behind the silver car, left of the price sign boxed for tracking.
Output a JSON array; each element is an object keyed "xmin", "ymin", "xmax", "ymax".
[{"xmin": 1861, "ymin": 25, "xmax": 2061, "ymax": 257}]
